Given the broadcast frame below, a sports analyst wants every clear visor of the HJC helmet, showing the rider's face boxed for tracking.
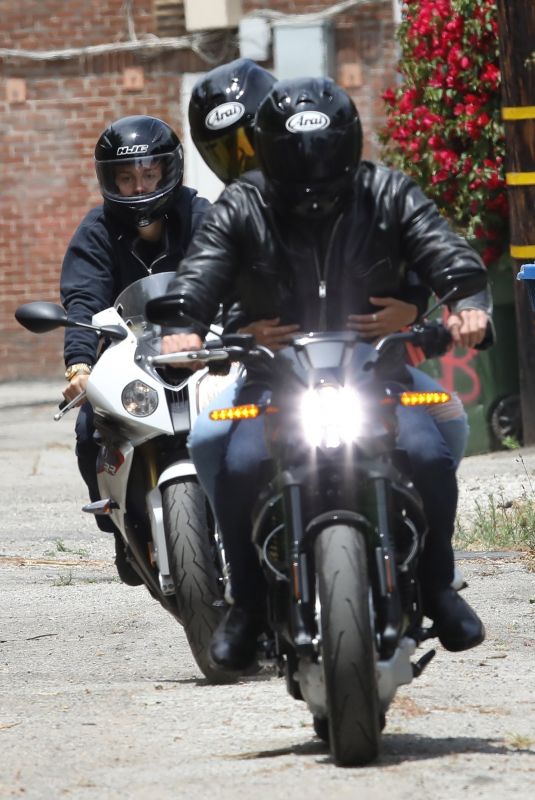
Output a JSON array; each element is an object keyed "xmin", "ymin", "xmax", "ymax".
[{"xmin": 95, "ymin": 148, "xmax": 182, "ymax": 201}]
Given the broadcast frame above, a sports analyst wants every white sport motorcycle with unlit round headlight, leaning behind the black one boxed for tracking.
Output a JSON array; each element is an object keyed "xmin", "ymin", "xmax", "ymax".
[{"xmin": 15, "ymin": 272, "xmax": 235, "ymax": 683}]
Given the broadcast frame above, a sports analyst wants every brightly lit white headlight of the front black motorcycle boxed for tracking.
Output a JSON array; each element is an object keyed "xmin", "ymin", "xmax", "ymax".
[{"xmin": 301, "ymin": 385, "xmax": 364, "ymax": 447}]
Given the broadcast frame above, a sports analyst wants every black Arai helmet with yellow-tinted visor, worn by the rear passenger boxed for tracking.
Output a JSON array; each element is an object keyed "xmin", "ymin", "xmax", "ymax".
[{"xmin": 189, "ymin": 58, "xmax": 275, "ymax": 183}]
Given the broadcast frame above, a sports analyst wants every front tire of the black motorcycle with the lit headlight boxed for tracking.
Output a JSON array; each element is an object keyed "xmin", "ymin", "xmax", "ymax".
[{"xmin": 315, "ymin": 525, "xmax": 381, "ymax": 767}]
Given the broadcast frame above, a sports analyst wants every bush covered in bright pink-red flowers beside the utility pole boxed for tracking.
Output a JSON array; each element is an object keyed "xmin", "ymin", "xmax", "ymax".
[{"xmin": 380, "ymin": 0, "xmax": 509, "ymax": 265}]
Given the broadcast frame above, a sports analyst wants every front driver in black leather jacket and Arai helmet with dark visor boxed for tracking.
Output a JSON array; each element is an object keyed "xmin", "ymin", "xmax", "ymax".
[{"xmin": 157, "ymin": 79, "xmax": 490, "ymax": 669}]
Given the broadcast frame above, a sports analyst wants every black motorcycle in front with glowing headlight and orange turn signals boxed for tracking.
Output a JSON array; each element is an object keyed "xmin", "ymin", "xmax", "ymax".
[{"xmin": 147, "ymin": 282, "xmax": 486, "ymax": 766}]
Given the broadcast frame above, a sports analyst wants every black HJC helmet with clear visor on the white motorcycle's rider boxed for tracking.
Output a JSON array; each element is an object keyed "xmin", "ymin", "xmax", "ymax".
[{"xmin": 95, "ymin": 116, "xmax": 184, "ymax": 228}]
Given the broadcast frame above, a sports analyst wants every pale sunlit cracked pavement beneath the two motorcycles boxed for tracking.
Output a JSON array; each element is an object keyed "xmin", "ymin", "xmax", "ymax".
[{"xmin": 0, "ymin": 382, "xmax": 535, "ymax": 800}]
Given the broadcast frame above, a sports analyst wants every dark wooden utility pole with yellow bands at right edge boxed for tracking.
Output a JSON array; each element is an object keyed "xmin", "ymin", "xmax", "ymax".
[{"xmin": 497, "ymin": 0, "xmax": 535, "ymax": 445}]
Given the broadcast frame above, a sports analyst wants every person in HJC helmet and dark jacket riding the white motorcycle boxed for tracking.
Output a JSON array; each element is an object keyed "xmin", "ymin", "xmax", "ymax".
[{"xmin": 60, "ymin": 115, "xmax": 210, "ymax": 585}]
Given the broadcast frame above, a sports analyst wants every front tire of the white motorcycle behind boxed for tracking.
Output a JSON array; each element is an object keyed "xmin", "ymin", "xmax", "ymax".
[{"xmin": 162, "ymin": 479, "xmax": 236, "ymax": 683}]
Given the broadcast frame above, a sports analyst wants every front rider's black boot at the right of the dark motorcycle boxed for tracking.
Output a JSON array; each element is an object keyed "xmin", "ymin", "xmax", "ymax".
[{"xmin": 424, "ymin": 586, "xmax": 485, "ymax": 652}]
